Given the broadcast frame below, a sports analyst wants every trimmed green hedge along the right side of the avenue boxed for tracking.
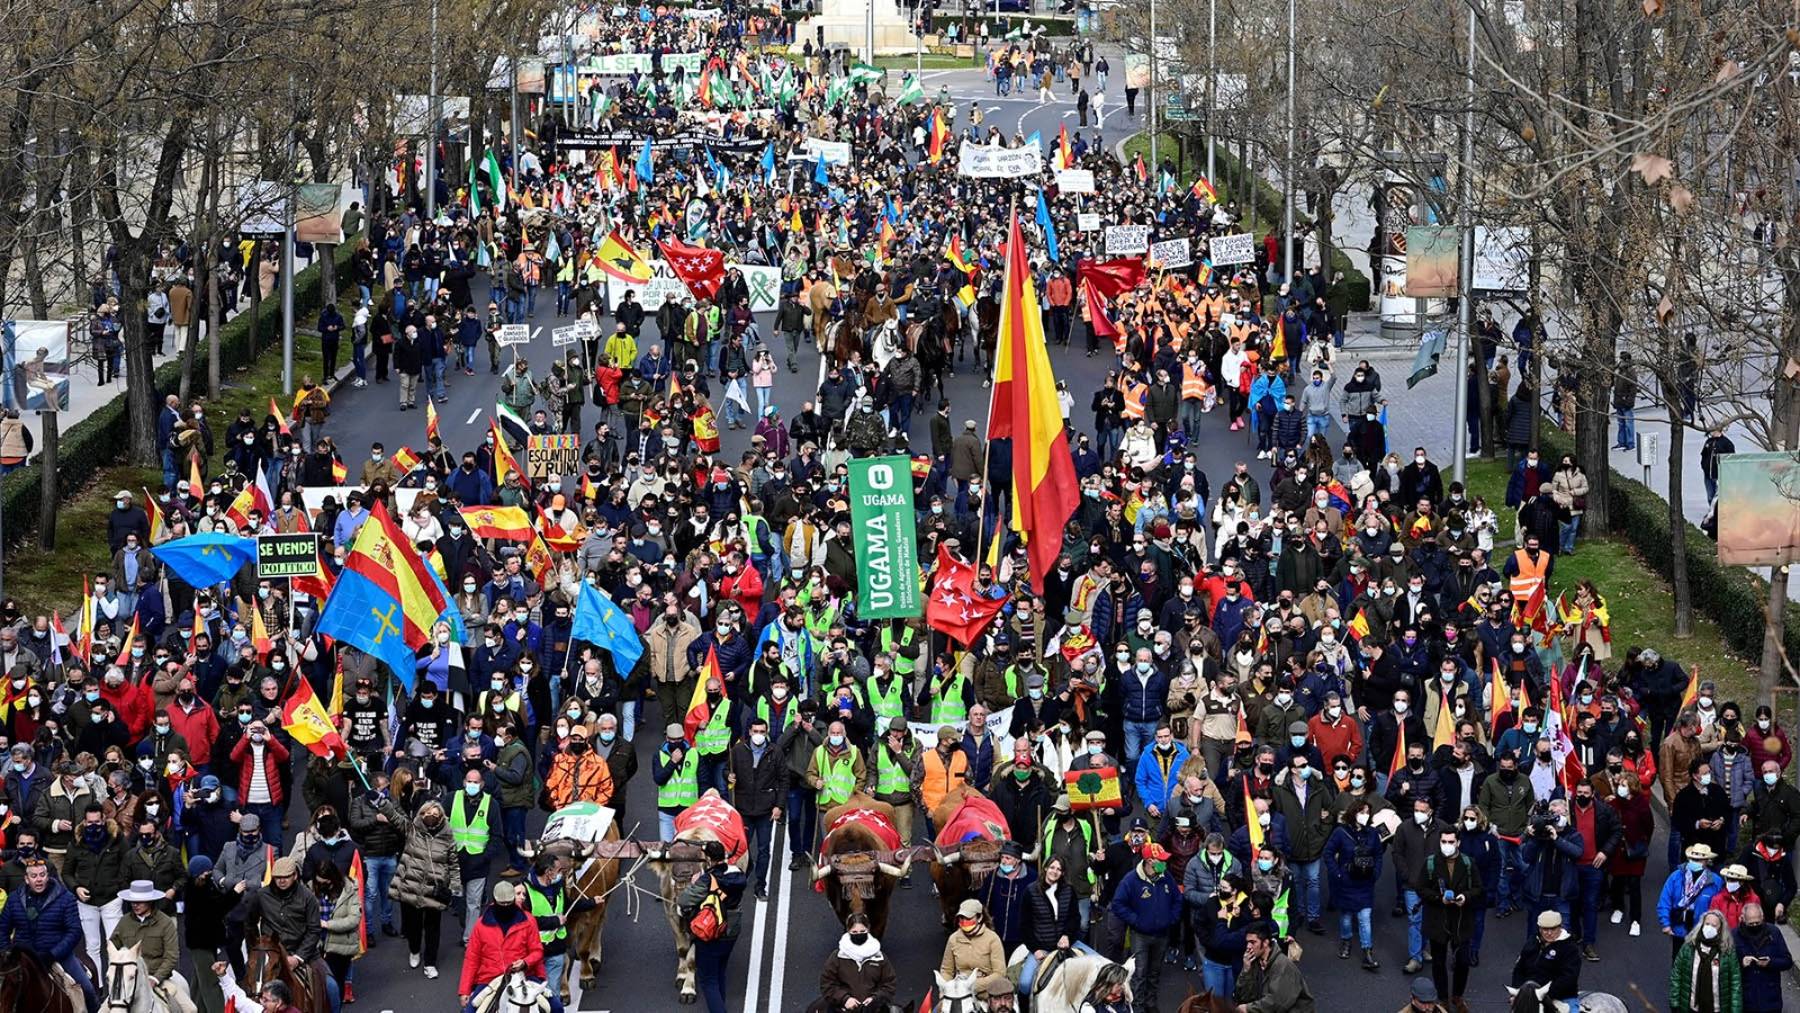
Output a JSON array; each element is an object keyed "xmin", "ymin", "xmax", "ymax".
[{"xmin": 1539, "ymin": 417, "xmax": 1800, "ymax": 664}]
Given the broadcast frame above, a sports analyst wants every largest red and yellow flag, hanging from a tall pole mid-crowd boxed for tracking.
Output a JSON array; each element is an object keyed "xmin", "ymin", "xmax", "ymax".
[{"xmin": 988, "ymin": 211, "xmax": 1080, "ymax": 594}]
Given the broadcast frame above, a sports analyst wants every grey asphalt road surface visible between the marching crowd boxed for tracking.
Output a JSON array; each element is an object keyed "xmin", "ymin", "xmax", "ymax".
[{"xmin": 306, "ymin": 72, "xmax": 1713, "ymax": 1013}]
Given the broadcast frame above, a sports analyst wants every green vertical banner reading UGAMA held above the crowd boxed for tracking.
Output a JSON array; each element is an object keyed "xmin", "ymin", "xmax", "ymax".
[{"xmin": 850, "ymin": 455, "xmax": 925, "ymax": 619}]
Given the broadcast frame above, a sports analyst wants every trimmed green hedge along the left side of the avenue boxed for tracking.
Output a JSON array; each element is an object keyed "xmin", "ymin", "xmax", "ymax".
[{"xmin": 0, "ymin": 243, "xmax": 355, "ymax": 543}]
